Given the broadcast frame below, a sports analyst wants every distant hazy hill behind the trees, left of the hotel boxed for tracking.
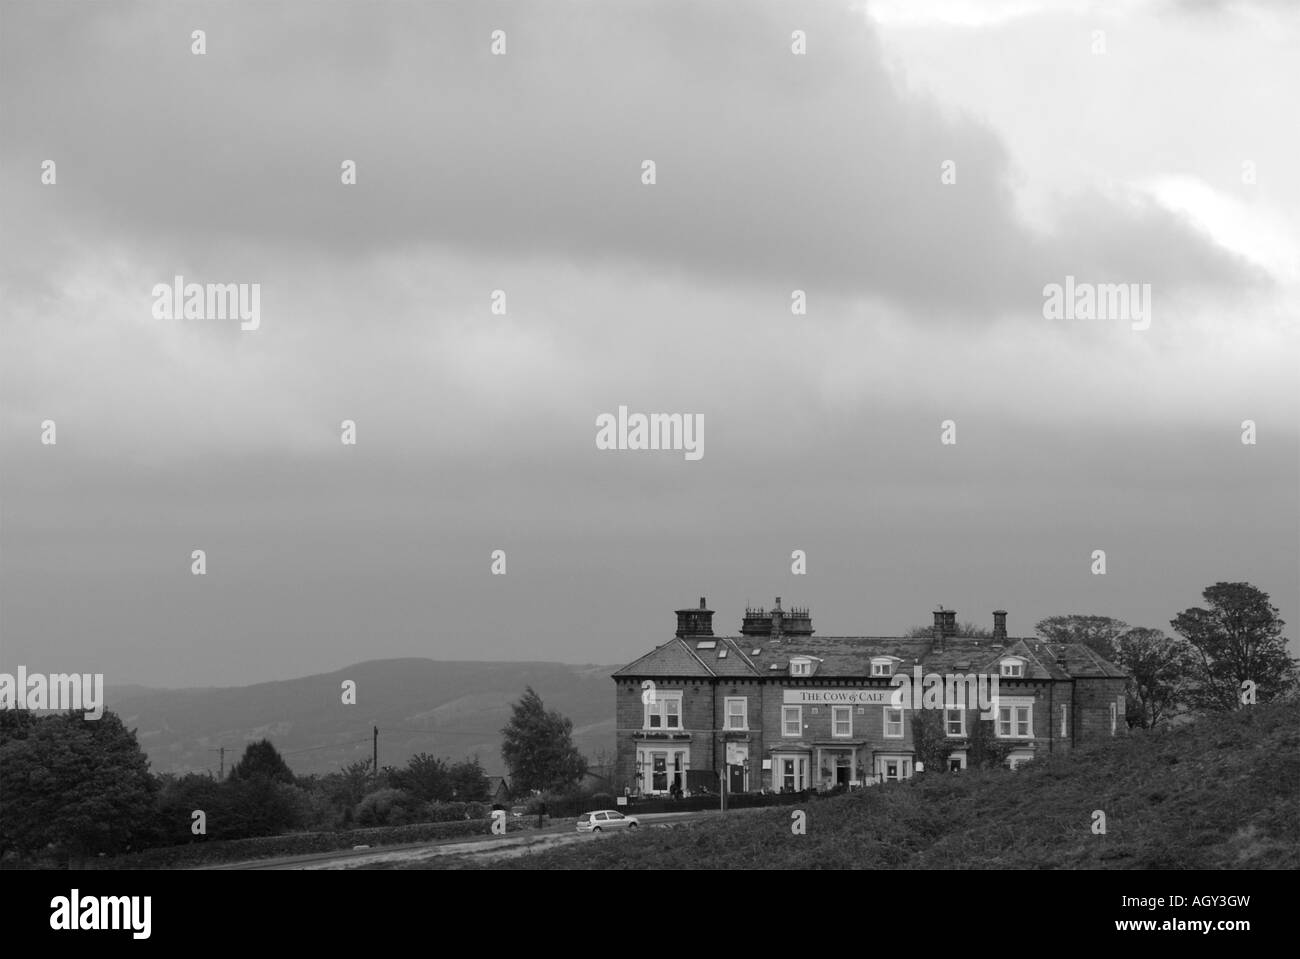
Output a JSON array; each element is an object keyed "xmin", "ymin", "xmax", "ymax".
[{"xmin": 107, "ymin": 659, "xmax": 619, "ymax": 774}]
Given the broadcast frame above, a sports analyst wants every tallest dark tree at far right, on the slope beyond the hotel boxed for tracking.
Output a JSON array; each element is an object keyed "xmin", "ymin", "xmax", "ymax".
[{"xmin": 1170, "ymin": 582, "xmax": 1296, "ymax": 711}]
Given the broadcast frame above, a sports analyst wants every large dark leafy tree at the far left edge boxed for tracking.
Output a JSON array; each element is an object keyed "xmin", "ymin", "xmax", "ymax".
[{"xmin": 0, "ymin": 710, "xmax": 157, "ymax": 858}]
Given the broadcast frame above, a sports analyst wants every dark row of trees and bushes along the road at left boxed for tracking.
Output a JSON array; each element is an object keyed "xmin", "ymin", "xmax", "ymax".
[{"xmin": 0, "ymin": 710, "xmax": 490, "ymax": 863}]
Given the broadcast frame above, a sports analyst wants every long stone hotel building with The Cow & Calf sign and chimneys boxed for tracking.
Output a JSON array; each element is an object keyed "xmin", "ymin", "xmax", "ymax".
[{"xmin": 614, "ymin": 596, "xmax": 1126, "ymax": 795}]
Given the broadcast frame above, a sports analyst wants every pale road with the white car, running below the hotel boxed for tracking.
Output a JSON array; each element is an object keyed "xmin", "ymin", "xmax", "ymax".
[{"xmin": 204, "ymin": 810, "xmax": 754, "ymax": 869}]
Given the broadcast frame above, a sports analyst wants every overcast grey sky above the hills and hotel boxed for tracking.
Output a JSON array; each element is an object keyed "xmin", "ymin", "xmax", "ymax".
[{"xmin": 0, "ymin": 0, "xmax": 1300, "ymax": 686}]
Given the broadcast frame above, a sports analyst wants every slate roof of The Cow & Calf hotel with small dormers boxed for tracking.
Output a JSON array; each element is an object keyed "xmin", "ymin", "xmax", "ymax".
[{"xmin": 614, "ymin": 635, "xmax": 1126, "ymax": 680}]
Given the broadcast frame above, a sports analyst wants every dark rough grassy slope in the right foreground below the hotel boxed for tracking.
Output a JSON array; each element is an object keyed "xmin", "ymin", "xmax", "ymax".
[{"xmin": 452, "ymin": 700, "xmax": 1300, "ymax": 869}]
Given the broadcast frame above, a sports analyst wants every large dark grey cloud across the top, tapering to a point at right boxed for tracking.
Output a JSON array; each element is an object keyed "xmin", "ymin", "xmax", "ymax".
[{"xmin": 0, "ymin": 1, "xmax": 1256, "ymax": 322}]
